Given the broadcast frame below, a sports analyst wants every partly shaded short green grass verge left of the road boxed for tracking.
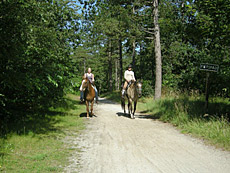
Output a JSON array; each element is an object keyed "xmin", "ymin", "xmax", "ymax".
[{"xmin": 0, "ymin": 95, "xmax": 85, "ymax": 173}]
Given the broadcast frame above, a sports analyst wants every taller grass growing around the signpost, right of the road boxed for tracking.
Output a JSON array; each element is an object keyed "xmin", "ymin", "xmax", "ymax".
[{"xmin": 103, "ymin": 92, "xmax": 230, "ymax": 151}]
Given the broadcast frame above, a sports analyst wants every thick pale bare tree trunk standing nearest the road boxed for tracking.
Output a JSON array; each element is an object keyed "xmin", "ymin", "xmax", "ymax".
[{"xmin": 153, "ymin": 0, "xmax": 162, "ymax": 100}]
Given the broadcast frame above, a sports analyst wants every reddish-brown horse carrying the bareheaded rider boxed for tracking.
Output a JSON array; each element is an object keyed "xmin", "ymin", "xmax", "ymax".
[{"xmin": 82, "ymin": 78, "xmax": 95, "ymax": 118}]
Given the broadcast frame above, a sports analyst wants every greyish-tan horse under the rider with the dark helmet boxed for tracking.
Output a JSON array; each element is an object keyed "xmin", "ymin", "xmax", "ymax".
[{"xmin": 121, "ymin": 81, "xmax": 142, "ymax": 119}]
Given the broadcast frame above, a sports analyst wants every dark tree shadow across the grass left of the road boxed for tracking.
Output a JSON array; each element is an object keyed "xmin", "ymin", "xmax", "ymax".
[{"xmin": 0, "ymin": 98, "xmax": 80, "ymax": 138}]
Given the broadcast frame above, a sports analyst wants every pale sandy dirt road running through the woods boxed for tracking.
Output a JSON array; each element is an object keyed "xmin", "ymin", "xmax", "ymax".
[{"xmin": 65, "ymin": 99, "xmax": 230, "ymax": 173}]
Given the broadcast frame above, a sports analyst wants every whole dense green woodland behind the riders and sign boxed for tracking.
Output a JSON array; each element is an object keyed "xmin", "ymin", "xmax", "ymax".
[{"xmin": 0, "ymin": 0, "xmax": 230, "ymax": 132}]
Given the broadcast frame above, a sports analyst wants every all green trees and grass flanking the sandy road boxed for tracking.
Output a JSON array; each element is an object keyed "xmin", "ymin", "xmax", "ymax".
[{"xmin": 0, "ymin": 0, "xmax": 230, "ymax": 172}]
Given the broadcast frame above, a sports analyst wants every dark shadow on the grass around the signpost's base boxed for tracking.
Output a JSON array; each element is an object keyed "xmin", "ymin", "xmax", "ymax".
[{"xmin": 140, "ymin": 97, "xmax": 230, "ymax": 121}]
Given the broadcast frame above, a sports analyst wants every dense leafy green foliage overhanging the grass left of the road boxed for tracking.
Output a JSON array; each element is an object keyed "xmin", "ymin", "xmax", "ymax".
[{"xmin": 0, "ymin": 0, "xmax": 78, "ymax": 133}]
